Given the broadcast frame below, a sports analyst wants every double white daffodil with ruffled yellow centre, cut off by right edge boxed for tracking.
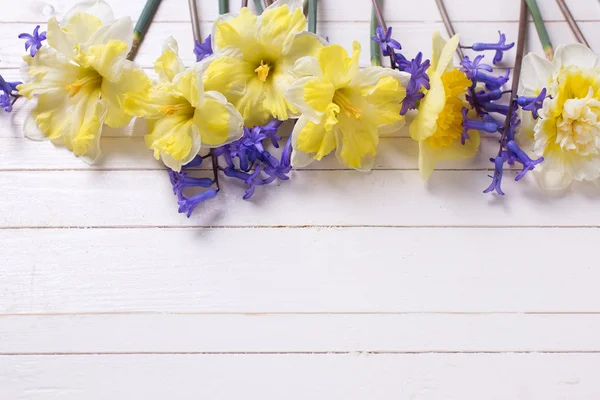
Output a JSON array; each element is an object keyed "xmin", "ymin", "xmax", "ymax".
[{"xmin": 519, "ymin": 44, "xmax": 600, "ymax": 189}]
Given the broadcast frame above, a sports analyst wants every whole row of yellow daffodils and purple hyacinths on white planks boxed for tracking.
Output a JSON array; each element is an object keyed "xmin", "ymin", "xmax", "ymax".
[{"xmin": 0, "ymin": 0, "xmax": 600, "ymax": 217}]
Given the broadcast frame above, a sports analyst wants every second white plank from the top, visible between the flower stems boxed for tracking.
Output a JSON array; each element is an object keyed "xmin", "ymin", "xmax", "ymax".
[{"xmin": 0, "ymin": 21, "xmax": 600, "ymax": 69}]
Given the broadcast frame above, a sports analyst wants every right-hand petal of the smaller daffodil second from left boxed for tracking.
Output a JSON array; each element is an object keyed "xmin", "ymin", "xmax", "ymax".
[{"xmin": 194, "ymin": 92, "xmax": 244, "ymax": 146}]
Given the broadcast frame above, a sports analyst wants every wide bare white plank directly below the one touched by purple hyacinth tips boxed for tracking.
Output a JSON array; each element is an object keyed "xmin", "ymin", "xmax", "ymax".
[{"xmin": 0, "ymin": 227, "xmax": 600, "ymax": 314}]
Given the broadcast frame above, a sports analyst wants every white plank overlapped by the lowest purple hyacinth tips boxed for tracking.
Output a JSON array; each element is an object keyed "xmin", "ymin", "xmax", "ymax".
[{"xmin": 0, "ymin": 170, "xmax": 600, "ymax": 228}]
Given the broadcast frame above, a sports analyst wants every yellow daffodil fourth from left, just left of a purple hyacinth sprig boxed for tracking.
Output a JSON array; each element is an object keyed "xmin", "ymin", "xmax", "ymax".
[{"xmin": 286, "ymin": 42, "xmax": 410, "ymax": 170}]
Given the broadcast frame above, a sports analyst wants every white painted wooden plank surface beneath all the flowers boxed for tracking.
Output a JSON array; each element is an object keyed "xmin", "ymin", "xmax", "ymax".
[{"xmin": 0, "ymin": 0, "xmax": 600, "ymax": 400}]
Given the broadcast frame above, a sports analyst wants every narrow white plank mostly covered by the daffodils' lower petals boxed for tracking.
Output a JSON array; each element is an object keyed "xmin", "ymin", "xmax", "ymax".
[{"xmin": 0, "ymin": 137, "xmax": 506, "ymax": 171}]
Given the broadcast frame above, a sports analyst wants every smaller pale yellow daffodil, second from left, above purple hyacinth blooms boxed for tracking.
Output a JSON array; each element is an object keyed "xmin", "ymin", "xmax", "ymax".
[{"xmin": 125, "ymin": 38, "xmax": 244, "ymax": 171}]
